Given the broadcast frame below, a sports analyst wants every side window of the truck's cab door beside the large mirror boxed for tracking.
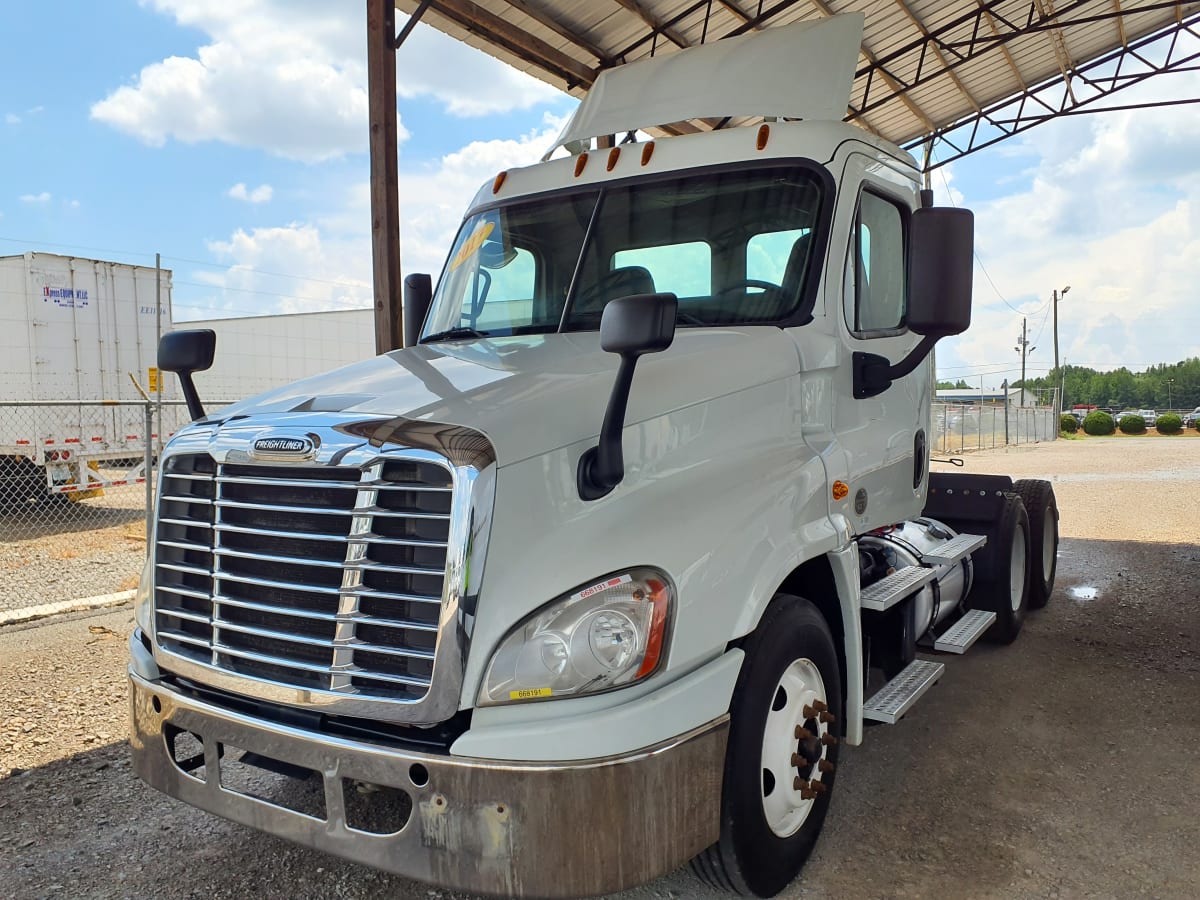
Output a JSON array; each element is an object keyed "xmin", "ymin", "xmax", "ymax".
[{"xmin": 847, "ymin": 191, "xmax": 908, "ymax": 332}]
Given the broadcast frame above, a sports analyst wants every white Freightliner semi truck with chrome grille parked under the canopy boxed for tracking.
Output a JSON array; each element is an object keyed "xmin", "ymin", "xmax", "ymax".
[{"xmin": 130, "ymin": 16, "xmax": 1057, "ymax": 896}]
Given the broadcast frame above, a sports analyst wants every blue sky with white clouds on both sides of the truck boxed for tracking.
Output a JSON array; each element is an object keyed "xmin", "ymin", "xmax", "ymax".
[{"xmin": 0, "ymin": 0, "xmax": 1200, "ymax": 386}]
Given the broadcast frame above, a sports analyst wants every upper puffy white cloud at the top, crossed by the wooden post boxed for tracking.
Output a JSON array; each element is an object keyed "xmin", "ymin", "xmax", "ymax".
[{"xmin": 91, "ymin": 0, "xmax": 560, "ymax": 162}]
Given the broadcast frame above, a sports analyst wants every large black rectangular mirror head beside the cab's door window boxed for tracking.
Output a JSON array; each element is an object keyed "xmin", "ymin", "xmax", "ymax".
[{"xmin": 907, "ymin": 206, "xmax": 974, "ymax": 338}]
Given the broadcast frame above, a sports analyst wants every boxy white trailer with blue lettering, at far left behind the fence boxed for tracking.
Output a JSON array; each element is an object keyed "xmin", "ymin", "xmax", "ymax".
[{"xmin": 0, "ymin": 252, "xmax": 178, "ymax": 499}]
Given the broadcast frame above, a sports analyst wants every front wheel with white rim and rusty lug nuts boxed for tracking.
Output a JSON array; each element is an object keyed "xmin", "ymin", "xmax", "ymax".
[{"xmin": 692, "ymin": 594, "xmax": 842, "ymax": 896}]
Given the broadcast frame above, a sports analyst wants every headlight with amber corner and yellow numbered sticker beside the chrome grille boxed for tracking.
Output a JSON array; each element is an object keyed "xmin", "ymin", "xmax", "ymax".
[{"xmin": 479, "ymin": 568, "xmax": 674, "ymax": 706}]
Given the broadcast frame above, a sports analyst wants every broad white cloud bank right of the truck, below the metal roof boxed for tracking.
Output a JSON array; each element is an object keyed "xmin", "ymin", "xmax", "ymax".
[{"xmin": 938, "ymin": 76, "xmax": 1200, "ymax": 376}]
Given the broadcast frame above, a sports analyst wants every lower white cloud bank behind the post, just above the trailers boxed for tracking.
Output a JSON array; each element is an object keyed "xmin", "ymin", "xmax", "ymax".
[{"xmin": 176, "ymin": 118, "xmax": 560, "ymax": 318}]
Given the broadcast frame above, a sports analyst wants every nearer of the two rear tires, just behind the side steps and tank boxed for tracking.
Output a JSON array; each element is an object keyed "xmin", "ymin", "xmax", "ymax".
[{"xmin": 967, "ymin": 493, "xmax": 1030, "ymax": 643}]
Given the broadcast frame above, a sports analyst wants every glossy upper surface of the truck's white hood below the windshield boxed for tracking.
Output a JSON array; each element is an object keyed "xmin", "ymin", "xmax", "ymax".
[{"xmin": 209, "ymin": 326, "xmax": 799, "ymax": 466}]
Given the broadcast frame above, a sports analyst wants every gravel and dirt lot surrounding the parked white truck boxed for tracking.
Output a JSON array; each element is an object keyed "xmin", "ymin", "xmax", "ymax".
[{"xmin": 0, "ymin": 438, "xmax": 1200, "ymax": 900}]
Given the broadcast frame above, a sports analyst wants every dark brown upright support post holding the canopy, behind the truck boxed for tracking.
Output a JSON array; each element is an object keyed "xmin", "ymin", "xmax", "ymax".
[{"xmin": 366, "ymin": 0, "xmax": 403, "ymax": 353}]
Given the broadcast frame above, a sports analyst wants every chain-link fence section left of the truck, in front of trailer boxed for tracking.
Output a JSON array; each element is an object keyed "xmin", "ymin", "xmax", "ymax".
[{"xmin": 0, "ymin": 401, "xmax": 204, "ymax": 612}]
